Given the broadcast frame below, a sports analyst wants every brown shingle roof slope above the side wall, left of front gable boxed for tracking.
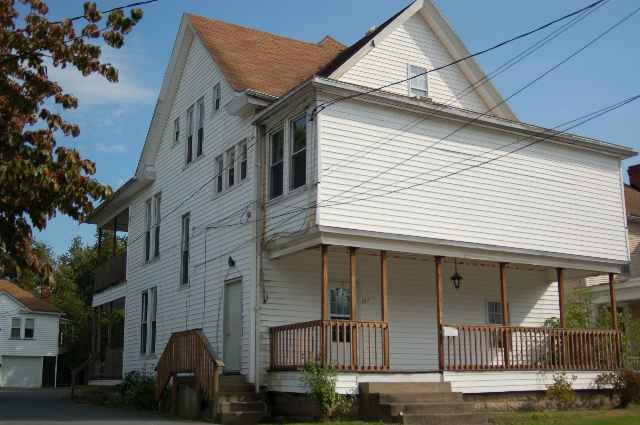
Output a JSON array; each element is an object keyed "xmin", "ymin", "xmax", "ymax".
[{"xmin": 186, "ymin": 14, "xmax": 345, "ymax": 97}]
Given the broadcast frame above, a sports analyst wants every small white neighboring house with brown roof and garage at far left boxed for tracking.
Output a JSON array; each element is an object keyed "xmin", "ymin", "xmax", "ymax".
[{"xmin": 0, "ymin": 280, "xmax": 62, "ymax": 388}]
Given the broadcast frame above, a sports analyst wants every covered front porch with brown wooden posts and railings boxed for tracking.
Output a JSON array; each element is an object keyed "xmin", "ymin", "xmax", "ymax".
[{"xmin": 269, "ymin": 245, "xmax": 623, "ymax": 379}]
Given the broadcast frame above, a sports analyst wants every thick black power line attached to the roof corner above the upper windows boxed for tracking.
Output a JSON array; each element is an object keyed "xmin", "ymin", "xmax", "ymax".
[{"xmin": 312, "ymin": 0, "xmax": 606, "ymax": 117}]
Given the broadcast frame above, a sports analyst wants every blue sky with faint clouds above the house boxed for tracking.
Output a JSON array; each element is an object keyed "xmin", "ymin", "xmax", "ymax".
[{"xmin": 36, "ymin": 0, "xmax": 640, "ymax": 253}]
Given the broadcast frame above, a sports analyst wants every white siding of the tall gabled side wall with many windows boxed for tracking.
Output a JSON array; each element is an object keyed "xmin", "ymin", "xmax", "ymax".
[{"xmin": 124, "ymin": 34, "xmax": 255, "ymax": 374}]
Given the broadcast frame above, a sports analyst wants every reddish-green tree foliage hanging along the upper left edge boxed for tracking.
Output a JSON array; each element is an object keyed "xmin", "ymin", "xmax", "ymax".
[{"xmin": 0, "ymin": 0, "xmax": 142, "ymax": 276}]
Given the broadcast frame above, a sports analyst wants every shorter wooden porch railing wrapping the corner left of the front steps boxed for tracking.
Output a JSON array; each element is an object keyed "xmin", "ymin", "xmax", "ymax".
[{"xmin": 270, "ymin": 320, "xmax": 389, "ymax": 371}]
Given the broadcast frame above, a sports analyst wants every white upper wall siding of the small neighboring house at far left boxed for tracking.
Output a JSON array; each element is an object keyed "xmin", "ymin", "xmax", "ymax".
[{"xmin": 0, "ymin": 292, "xmax": 59, "ymax": 357}]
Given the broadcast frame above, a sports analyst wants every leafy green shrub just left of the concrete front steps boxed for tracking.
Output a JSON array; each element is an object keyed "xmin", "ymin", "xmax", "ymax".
[{"xmin": 302, "ymin": 363, "xmax": 353, "ymax": 420}]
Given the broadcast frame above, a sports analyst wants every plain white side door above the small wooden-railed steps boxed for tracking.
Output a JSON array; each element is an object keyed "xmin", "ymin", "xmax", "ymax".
[{"xmin": 223, "ymin": 280, "xmax": 242, "ymax": 373}]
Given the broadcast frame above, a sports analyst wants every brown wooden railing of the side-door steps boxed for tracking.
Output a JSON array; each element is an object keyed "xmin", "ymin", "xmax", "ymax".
[{"xmin": 156, "ymin": 329, "xmax": 224, "ymax": 400}]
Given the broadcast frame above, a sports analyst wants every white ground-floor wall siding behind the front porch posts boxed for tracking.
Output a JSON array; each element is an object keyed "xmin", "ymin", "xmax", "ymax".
[{"xmin": 260, "ymin": 248, "xmax": 559, "ymax": 382}]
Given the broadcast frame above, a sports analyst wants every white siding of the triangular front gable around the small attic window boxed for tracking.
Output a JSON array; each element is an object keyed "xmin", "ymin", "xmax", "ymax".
[{"xmin": 339, "ymin": 13, "xmax": 487, "ymax": 112}]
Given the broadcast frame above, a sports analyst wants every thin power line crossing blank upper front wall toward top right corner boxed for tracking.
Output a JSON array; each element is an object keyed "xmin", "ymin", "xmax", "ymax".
[{"xmin": 327, "ymin": 2, "xmax": 640, "ymax": 208}]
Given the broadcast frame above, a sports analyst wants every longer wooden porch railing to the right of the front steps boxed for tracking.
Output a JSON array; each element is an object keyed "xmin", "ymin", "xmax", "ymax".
[{"xmin": 443, "ymin": 325, "xmax": 622, "ymax": 371}]
